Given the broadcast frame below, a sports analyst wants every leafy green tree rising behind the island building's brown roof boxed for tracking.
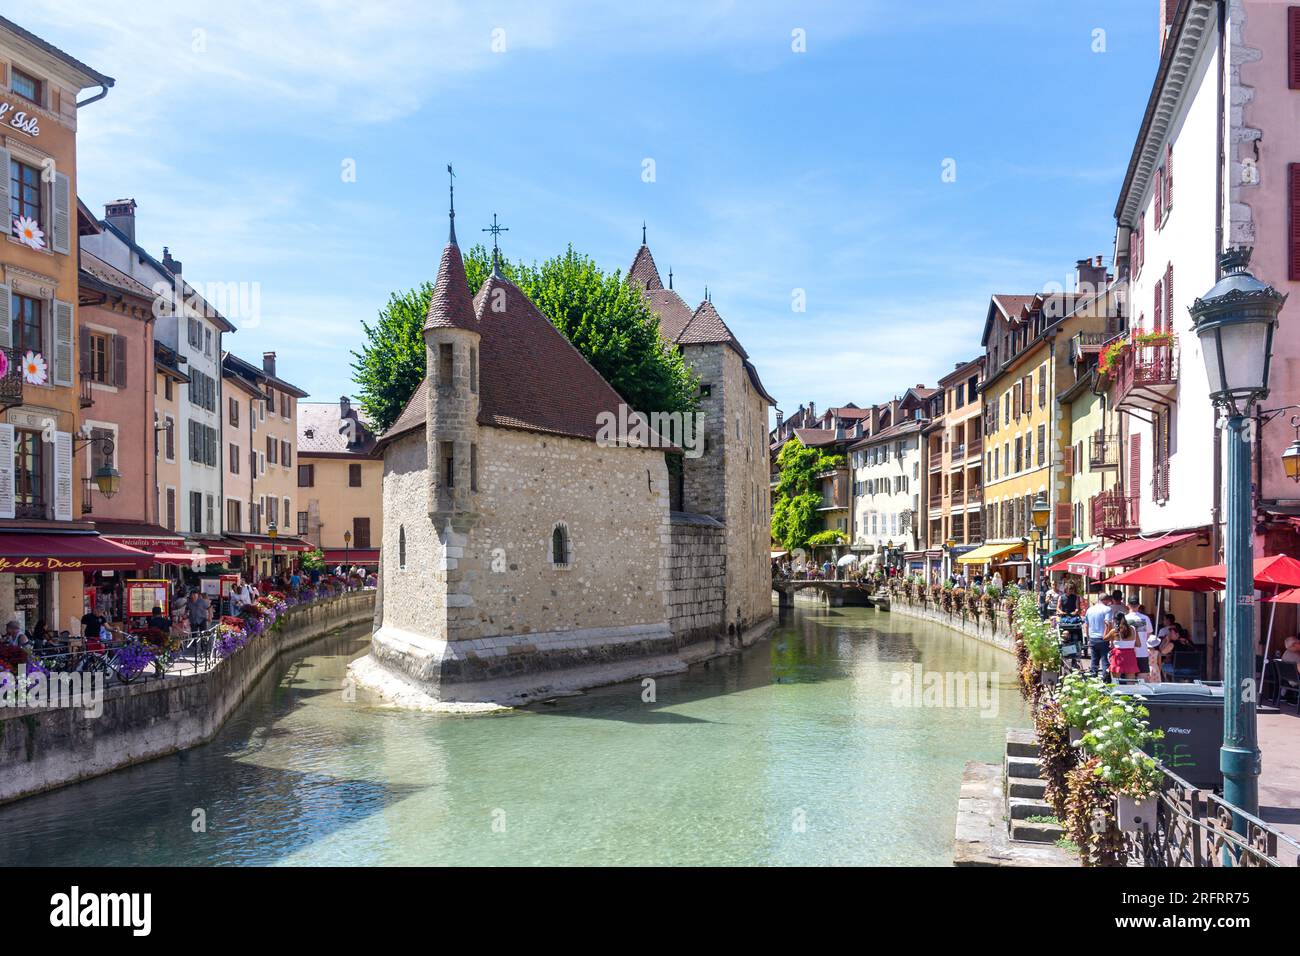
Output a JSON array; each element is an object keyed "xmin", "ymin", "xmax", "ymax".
[{"xmin": 352, "ymin": 245, "xmax": 698, "ymax": 431}]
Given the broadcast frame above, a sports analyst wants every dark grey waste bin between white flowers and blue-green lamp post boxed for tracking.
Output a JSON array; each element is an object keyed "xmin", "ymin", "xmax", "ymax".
[{"xmin": 1110, "ymin": 684, "xmax": 1223, "ymax": 791}]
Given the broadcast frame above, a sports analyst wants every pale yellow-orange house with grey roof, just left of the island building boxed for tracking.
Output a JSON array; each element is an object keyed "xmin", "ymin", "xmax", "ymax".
[{"xmin": 295, "ymin": 395, "xmax": 384, "ymax": 567}]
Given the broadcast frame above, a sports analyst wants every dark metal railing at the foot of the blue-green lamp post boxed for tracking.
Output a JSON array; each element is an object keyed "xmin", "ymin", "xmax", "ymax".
[{"xmin": 1125, "ymin": 765, "xmax": 1300, "ymax": 868}]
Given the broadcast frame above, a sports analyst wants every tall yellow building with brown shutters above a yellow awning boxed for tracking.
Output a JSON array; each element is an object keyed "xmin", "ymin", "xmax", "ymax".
[{"xmin": 965, "ymin": 258, "xmax": 1114, "ymax": 583}]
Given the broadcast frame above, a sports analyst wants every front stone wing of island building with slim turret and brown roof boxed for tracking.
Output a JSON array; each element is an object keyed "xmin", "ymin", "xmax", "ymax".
[{"xmin": 352, "ymin": 204, "xmax": 771, "ymax": 708}]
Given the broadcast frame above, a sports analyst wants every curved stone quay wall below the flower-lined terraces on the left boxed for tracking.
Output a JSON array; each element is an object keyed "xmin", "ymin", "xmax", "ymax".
[{"xmin": 0, "ymin": 591, "xmax": 374, "ymax": 804}]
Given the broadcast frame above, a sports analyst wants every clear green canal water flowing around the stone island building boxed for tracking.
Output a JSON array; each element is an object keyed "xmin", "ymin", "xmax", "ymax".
[{"xmin": 0, "ymin": 607, "xmax": 1028, "ymax": 866}]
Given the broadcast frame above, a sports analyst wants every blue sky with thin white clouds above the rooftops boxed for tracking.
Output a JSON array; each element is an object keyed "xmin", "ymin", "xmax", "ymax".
[{"xmin": 30, "ymin": 0, "xmax": 1158, "ymax": 412}]
